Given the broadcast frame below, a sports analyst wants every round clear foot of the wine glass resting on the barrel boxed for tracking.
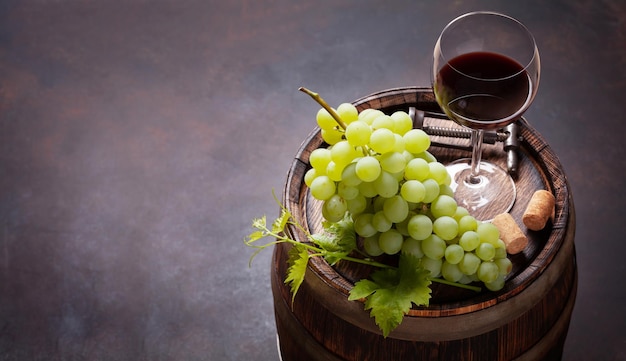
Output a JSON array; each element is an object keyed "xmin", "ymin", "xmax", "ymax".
[{"xmin": 446, "ymin": 159, "xmax": 517, "ymax": 222}]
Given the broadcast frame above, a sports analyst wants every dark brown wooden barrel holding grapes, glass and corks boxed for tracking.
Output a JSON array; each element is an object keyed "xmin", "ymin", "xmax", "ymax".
[{"xmin": 271, "ymin": 87, "xmax": 577, "ymax": 361}]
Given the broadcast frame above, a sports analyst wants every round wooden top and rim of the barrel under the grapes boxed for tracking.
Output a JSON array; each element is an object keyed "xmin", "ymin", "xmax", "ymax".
[{"xmin": 283, "ymin": 87, "xmax": 575, "ymax": 317}]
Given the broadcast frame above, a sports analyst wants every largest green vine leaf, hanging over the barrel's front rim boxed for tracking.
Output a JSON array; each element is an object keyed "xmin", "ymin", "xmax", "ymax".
[{"xmin": 348, "ymin": 253, "xmax": 431, "ymax": 337}]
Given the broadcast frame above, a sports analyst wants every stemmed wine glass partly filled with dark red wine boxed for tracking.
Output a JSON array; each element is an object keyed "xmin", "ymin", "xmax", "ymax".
[{"xmin": 432, "ymin": 11, "xmax": 540, "ymax": 221}]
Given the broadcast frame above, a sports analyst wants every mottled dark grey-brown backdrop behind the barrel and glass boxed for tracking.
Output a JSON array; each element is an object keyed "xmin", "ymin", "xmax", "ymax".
[{"xmin": 0, "ymin": 0, "xmax": 626, "ymax": 360}]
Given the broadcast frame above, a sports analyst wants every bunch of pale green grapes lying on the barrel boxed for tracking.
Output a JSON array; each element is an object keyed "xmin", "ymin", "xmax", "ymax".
[{"xmin": 304, "ymin": 103, "xmax": 512, "ymax": 290}]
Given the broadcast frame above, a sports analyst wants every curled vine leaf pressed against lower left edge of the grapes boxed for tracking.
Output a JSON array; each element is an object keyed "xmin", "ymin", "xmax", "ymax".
[{"xmin": 311, "ymin": 215, "xmax": 357, "ymax": 266}]
